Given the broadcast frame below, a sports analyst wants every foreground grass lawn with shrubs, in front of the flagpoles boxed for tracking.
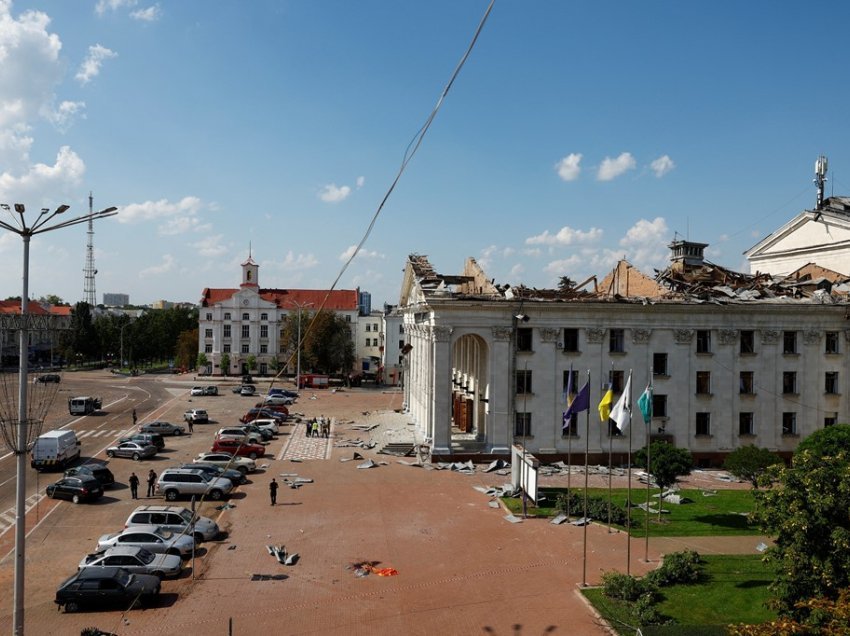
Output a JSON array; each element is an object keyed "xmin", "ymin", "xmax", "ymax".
[{"xmin": 584, "ymin": 555, "xmax": 776, "ymax": 636}]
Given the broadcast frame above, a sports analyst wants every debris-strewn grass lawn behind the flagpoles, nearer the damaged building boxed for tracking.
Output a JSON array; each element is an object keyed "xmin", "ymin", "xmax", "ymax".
[{"xmin": 502, "ymin": 488, "xmax": 761, "ymax": 537}]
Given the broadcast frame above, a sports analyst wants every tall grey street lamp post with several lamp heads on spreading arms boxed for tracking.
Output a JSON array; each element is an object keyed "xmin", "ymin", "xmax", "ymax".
[{"xmin": 0, "ymin": 203, "xmax": 118, "ymax": 636}]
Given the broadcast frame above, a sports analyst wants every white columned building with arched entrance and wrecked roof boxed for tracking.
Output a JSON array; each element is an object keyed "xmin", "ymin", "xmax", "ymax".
[{"xmin": 398, "ymin": 241, "xmax": 850, "ymax": 466}]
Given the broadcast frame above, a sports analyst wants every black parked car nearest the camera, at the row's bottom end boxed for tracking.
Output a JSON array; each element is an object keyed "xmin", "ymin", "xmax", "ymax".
[{"xmin": 54, "ymin": 567, "xmax": 160, "ymax": 612}]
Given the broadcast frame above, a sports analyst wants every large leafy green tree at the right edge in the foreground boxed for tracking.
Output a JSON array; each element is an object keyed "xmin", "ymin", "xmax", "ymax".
[{"xmin": 753, "ymin": 442, "xmax": 850, "ymax": 620}]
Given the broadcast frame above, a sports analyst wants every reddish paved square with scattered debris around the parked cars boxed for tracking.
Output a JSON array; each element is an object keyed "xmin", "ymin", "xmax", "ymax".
[{"xmin": 0, "ymin": 376, "xmax": 756, "ymax": 635}]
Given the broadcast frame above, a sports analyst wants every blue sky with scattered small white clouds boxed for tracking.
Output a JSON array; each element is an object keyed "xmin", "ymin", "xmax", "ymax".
[{"xmin": 0, "ymin": 0, "xmax": 850, "ymax": 306}]
